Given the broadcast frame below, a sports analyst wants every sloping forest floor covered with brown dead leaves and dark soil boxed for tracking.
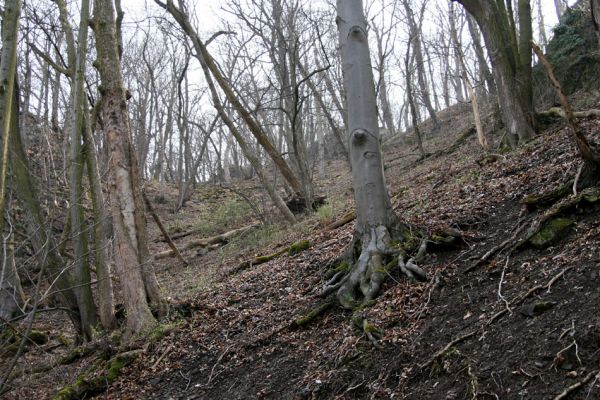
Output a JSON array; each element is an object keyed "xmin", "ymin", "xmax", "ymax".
[{"xmin": 7, "ymin": 97, "xmax": 600, "ymax": 400}]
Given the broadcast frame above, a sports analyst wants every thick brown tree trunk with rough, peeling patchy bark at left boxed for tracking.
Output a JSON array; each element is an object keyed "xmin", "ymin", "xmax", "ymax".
[{"xmin": 93, "ymin": 0, "xmax": 164, "ymax": 336}]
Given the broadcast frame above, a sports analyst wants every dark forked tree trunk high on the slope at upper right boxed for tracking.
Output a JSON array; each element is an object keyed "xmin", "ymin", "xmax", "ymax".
[{"xmin": 453, "ymin": 0, "xmax": 535, "ymax": 146}]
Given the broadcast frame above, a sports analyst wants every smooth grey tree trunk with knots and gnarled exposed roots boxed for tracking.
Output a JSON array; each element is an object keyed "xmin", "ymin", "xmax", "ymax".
[{"xmin": 332, "ymin": 0, "xmax": 412, "ymax": 308}]
